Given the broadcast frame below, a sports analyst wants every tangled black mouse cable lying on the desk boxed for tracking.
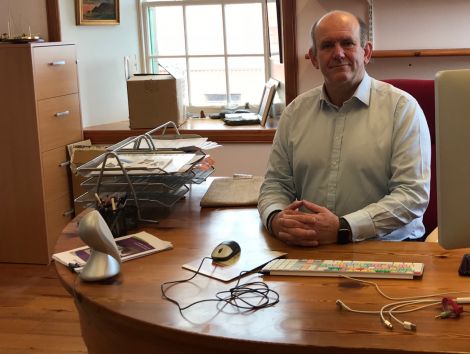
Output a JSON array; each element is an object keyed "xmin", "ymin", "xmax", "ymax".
[{"xmin": 160, "ymin": 257, "xmax": 279, "ymax": 315}]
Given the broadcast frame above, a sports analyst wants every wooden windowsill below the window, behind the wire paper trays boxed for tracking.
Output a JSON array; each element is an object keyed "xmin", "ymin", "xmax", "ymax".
[{"xmin": 83, "ymin": 118, "xmax": 279, "ymax": 144}]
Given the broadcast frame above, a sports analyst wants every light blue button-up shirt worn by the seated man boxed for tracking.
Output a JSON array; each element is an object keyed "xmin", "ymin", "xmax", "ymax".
[{"xmin": 258, "ymin": 74, "xmax": 431, "ymax": 241}]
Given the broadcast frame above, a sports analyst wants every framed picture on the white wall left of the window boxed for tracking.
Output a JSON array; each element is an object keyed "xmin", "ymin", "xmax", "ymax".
[{"xmin": 75, "ymin": 0, "xmax": 119, "ymax": 25}]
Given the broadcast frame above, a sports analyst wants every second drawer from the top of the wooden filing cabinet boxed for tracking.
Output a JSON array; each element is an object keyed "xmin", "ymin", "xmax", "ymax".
[{"xmin": 37, "ymin": 93, "xmax": 82, "ymax": 151}]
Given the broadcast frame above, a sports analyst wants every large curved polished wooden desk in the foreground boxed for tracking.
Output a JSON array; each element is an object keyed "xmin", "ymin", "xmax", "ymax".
[{"xmin": 56, "ymin": 183, "xmax": 470, "ymax": 354}]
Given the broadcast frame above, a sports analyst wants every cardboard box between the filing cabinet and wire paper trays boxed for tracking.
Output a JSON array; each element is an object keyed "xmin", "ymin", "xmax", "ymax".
[{"xmin": 67, "ymin": 140, "xmax": 106, "ymax": 215}]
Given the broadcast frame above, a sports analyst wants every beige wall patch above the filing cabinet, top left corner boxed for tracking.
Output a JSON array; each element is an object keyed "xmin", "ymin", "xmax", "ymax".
[{"xmin": 0, "ymin": 0, "xmax": 48, "ymax": 40}]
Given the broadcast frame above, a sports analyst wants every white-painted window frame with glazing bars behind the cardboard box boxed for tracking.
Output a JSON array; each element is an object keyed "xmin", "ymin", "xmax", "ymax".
[{"xmin": 139, "ymin": 0, "xmax": 271, "ymax": 109}]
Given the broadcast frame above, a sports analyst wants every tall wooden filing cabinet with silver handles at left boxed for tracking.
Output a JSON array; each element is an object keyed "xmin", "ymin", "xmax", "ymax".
[{"xmin": 0, "ymin": 42, "xmax": 82, "ymax": 264}]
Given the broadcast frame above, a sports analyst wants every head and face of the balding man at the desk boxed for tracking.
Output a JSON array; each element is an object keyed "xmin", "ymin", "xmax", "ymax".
[{"xmin": 310, "ymin": 13, "xmax": 372, "ymax": 86}]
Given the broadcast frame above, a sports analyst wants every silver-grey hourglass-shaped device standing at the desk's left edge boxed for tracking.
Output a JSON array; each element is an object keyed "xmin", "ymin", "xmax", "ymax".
[{"xmin": 78, "ymin": 210, "xmax": 121, "ymax": 281}]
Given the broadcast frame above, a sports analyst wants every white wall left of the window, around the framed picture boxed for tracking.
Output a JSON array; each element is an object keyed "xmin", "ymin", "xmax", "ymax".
[{"xmin": 59, "ymin": 0, "xmax": 140, "ymax": 127}]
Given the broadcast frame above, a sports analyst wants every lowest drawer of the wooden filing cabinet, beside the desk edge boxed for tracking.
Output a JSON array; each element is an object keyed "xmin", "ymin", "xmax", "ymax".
[{"xmin": 46, "ymin": 195, "xmax": 73, "ymax": 259}]
